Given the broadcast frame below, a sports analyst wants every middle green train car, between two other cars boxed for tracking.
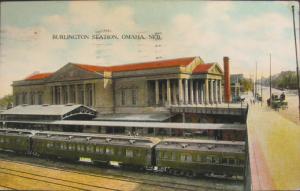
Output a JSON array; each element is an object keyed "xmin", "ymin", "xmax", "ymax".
[{"xmin": 32, "ymin": 132, "xmax": 159, "ymax": 167}]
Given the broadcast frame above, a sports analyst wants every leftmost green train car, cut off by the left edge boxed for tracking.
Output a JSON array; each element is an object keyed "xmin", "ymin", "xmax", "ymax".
[{"xmin": 0, "ymin": 129, "xmax": 34, "ymax": 154}]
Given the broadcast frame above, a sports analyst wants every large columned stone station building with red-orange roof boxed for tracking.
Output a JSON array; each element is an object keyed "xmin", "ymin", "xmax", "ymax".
[{"xmin": 12, "ymin": 57, "xmax": 228, "ymax": 114}]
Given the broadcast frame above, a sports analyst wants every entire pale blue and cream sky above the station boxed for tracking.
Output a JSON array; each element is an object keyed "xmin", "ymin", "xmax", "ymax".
[{"xmin": 0, "ymin": 0, "xmax": 299, "ymax": 97}]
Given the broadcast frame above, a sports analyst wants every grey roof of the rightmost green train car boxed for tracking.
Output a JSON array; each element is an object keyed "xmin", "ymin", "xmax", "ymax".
[{"xmin": 156, "ymin": 138, "xmax": 245, "ymax": 153}]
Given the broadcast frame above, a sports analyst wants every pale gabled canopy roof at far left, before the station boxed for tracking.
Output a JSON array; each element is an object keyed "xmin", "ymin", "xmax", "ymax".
[{"xmin": 0, "ymin": 104, "xmax": 97, "ymax": 120}]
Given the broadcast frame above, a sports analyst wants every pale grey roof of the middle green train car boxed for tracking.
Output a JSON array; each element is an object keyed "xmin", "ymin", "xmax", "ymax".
[{"xmin": 33, "ymin": 131, "xmax": 160, "ymax": 147}]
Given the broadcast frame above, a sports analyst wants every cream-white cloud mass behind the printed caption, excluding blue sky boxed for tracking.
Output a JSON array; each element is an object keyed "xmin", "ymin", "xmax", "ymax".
[{"xmin": 0, "ymin": 1, "xmax": 294, "ymax": 96}]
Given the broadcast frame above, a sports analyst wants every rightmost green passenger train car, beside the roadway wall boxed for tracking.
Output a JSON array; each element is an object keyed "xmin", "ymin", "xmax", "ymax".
[{"xmin": 155, "ymin": 139, "xmax": 245, "ymax": 176}]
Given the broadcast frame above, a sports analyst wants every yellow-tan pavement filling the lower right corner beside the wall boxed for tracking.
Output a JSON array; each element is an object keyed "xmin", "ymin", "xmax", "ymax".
[{"xmin": 247, "ymin": 104, "xmax": 300, "ymax": 190}]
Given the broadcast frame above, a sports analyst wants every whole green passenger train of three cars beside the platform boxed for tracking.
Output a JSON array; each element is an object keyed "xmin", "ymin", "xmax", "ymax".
[{"xmin": 0, "ymin": 129, "xmax": 245, "ymax": 176}]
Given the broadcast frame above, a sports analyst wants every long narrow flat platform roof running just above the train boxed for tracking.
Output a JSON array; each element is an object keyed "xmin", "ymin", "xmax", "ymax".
[{"xmin": 2, "ymin": 120, "xmax": 246, "ymax": 131}]
